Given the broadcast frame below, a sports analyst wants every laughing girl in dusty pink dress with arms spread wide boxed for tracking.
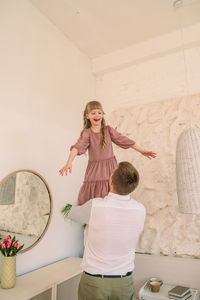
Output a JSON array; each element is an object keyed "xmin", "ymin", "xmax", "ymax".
[{"xmin": 59, "ymin": 101, "xmax": 156, "ymax": 205}]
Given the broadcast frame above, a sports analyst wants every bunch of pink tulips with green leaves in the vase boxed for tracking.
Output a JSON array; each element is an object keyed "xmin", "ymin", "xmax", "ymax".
[{"xmin": 0, "ymin": 234, "xmax": 24, "ymax": 257}]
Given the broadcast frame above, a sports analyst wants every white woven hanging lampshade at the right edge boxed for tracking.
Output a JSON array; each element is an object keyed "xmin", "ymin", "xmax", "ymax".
[{"xmin": 176, "ymin": 128, "xmax": 200, "ymax": 214}]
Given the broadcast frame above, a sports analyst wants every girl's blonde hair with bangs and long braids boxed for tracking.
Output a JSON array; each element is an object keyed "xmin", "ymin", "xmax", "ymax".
[{"xmin": 83, "ymin": 101, "xmax": 106, "ymax": 148}]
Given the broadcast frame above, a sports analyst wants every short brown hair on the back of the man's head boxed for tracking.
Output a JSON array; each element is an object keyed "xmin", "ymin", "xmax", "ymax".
[{"xmin": 112, "ymin": 161, "xmax": 139, "ymax": 195}]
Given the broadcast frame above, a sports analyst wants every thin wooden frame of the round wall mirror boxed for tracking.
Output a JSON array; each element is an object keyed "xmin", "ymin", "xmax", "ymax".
[{"xmin": 0, "ymin": 169, "xmax": 53, "ymax": 254}]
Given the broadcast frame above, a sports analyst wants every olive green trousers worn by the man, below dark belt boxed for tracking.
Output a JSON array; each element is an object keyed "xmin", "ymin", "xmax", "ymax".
[{"xmin": 78, "ymin": 272, "xmax": 136, "ymax": 300}]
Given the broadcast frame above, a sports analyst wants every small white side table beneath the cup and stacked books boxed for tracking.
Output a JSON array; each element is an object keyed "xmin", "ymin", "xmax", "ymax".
[{"xmin": 139, "ymin": 282, "xmax": 200, "ymax": 300}]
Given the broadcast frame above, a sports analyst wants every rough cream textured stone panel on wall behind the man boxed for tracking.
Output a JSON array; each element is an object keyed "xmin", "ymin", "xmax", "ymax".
[{"xmin": 109, "ymin": 94, "xmax": 200, "ymax": 257}]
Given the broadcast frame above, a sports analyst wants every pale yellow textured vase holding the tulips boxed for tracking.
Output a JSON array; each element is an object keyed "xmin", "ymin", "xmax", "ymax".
[{"xmin": 1, "ymin": 256, "xmax": 16, "ymax": 289}]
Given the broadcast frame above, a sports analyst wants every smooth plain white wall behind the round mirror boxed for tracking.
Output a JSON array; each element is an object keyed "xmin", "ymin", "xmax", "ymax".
[{"xmin": 0, "ymin": 0, "xmax": 94, "ymax": 274}]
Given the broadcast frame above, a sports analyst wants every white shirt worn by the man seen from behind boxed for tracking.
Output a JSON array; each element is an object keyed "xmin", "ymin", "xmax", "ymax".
[{"xmin": 69, "ymin": 193, "xmax": 146, "ymax": 275}]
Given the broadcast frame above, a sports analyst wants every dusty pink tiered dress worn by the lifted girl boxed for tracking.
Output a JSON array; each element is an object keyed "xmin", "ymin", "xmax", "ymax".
[{"xmin": 71, "ymin": 126, "xmax": 135, "ymax": 205}]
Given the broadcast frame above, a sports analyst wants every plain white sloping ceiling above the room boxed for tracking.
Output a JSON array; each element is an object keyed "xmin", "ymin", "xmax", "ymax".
[{"xmin": 30, "ymin": 0, "xmax": 200, "ymax": 58}]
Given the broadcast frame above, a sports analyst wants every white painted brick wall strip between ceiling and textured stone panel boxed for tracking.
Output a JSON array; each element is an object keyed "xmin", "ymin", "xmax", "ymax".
[{"xmin": 93, "ymin": 23, "xmax": 200, "ymax": 115}]
